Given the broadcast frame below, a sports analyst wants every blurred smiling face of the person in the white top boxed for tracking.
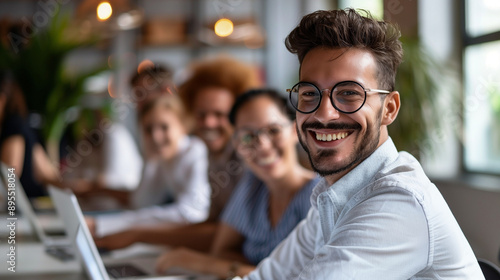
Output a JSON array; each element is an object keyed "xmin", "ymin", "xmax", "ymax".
[{"xmin": 141, "ymin": 106, "xmax": 185, "ymax": 159}]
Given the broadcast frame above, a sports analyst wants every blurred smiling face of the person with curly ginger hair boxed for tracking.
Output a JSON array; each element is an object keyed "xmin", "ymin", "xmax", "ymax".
[{"xmin": 193, "ymin": 88, "xmax": 234, "ymax": 154}]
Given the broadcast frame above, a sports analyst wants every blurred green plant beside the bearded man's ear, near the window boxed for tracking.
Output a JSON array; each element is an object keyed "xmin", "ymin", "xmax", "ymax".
[{"xmin": 389, "ymin": 38, "xmax": 461, "ymax": 158}]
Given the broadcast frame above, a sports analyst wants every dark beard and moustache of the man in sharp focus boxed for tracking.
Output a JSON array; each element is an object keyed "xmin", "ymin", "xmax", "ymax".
[{"xmin": 297, "ymin": 114, "xmax": 382, "ymax": 177}]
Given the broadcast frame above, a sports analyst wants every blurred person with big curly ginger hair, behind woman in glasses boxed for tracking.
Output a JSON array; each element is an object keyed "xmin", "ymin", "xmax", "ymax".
[{"xmin": 179, "ymin": 56, "xmax": 260, "ymax": 221}]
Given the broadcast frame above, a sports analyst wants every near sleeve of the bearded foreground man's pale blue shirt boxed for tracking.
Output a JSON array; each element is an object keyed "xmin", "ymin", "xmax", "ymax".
[{"xmin": 296, "ymin": 190, "xmax": 432, "ymax": 279}]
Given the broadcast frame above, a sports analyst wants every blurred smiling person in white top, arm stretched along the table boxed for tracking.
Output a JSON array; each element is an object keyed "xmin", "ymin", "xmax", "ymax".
[{"xmin": 89, "ymin": 94, "xmax": 210, "ymax": 236}]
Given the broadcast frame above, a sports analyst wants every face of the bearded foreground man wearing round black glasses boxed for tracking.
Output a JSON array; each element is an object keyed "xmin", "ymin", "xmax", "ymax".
[{"xmin": 297, "ymin": 48, "xmax": 390, "ymax": 183}]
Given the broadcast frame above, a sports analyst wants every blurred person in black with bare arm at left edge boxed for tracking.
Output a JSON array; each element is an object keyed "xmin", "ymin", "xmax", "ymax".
[{"xmin": 0, "ymin": 70, "xmax": 61, "ymax": 198}]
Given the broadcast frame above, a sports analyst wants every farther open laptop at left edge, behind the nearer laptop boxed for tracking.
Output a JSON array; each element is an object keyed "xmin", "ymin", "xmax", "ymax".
[{"xmin": 0, "ymin": 163, "xmax": 73, "ymax": 261}]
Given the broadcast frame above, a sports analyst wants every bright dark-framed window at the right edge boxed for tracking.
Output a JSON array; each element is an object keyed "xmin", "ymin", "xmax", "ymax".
[{"xmin": 463, "ymin": 0, "xmax": 500, "ymax": 174}]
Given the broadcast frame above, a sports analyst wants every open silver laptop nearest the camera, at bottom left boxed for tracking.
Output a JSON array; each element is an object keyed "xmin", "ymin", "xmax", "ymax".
[{"xmin": 49, "ymin": 187, "xmax": 199, "ymax": 280}]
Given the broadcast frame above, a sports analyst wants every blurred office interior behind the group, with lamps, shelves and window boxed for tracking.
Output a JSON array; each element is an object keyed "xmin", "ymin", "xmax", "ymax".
[{"xmin": 0, "ymin": 0, "xmax": 500, "ymax": 264}]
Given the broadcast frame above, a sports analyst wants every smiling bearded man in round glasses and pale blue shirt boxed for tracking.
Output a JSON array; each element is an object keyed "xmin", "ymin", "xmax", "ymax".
[{"xmin": 242, "ymin": 9, "xmax": 484, "ymax": 280}]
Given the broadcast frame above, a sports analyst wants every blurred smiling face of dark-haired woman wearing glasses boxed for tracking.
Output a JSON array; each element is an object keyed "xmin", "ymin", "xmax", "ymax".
[{"xmin": 233, "ymin": 96, "xmax": 297, "ymax": 180}]
